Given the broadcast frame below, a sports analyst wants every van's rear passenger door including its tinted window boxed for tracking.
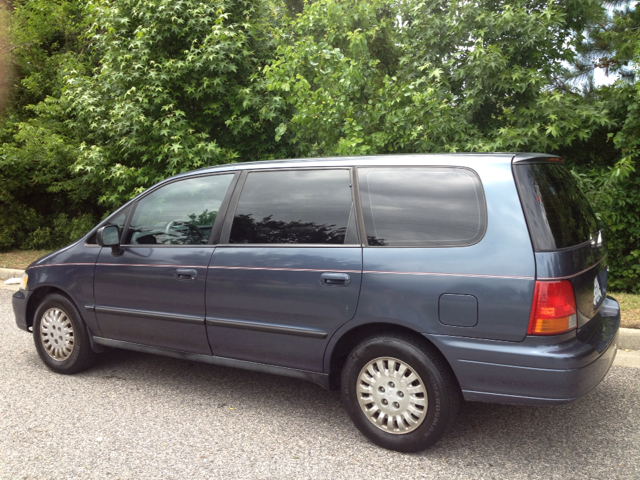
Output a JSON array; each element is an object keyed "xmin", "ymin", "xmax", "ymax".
[{"xmin": 206, "ymin": 168, "xmax": 362, "ymax": 372}]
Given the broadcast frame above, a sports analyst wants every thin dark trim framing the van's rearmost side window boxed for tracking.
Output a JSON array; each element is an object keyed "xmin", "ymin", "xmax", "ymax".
[{"xmin": 354, "ymin": 164, "xmax": 489, "ymax": 248}]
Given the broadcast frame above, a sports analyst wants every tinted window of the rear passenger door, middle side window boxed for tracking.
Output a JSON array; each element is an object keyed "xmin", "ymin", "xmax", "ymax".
[{"xmin": 229, "ymin": 170, "xmax": 357, "ymax": 244}]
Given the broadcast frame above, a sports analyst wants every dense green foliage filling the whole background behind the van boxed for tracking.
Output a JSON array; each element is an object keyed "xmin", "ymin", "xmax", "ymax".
[{"xmin": 0, "ymin": 0, "xmax": 640, "ymax": 291}]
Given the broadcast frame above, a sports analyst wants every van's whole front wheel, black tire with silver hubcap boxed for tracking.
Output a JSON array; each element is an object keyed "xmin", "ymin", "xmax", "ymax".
[{"xmin": 33, "ymin": 293, "xmax": 97, "ymax": 374}]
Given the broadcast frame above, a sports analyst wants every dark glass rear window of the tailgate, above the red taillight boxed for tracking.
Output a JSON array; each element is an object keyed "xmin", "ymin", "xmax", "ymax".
[{"xmin": 514, "ymin": 163, "xmax": 598, "ymax": 251}]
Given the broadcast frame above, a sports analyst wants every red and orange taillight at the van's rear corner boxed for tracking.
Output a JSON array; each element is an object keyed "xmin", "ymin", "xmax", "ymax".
[{"xmin": 527, "ymin": 280, "xmax": 577, "ymax": 335}]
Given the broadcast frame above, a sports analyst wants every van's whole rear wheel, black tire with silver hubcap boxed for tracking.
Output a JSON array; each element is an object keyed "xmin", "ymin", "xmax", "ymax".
[{"xmin": 341, "ymin": 334, "xmax": 461, "ymax": 452}]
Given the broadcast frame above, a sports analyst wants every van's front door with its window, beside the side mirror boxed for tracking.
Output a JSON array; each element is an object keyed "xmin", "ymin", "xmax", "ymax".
[{"xmin": 94, "ymin": 174, "xmax": 234, "ymax": 354}]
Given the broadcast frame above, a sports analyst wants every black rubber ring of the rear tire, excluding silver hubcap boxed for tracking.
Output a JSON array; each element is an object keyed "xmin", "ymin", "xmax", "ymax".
[{"xmin": 342, "ymin": 338, "xmax": 451, "ymax": 452}]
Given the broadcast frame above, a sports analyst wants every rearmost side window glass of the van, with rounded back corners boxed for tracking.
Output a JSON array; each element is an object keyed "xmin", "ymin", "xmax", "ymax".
[{"xmin": 358, "ymin": 167, "xmax": 487, "ymax": 247}]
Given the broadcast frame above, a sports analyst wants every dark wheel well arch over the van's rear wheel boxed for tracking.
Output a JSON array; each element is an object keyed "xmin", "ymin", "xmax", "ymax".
[{"xmin": 329, "ymin": 323, "xmax": 456, "ymax": 390}]
